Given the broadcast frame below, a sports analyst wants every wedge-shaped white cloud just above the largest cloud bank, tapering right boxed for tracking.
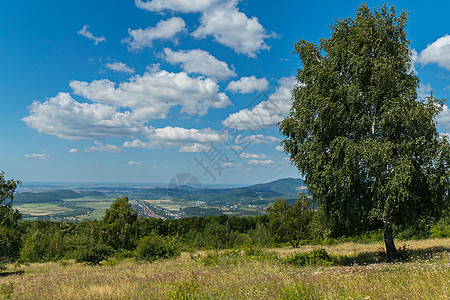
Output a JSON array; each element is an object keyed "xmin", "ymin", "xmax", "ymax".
[{"xmin": 164, "ymin": 48, "xmax": 236, "ymax": 80}]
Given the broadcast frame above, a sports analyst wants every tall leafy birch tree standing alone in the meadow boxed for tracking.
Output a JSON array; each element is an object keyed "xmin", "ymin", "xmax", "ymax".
[{"xmin": 279, "ymin": 5, "xmax": 450, "ymax": 261}]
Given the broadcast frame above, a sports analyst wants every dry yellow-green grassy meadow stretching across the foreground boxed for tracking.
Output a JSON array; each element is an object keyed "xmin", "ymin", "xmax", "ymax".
[{"xmin": 0, "ymin": 239, "xmax": 450, "ymax": 300}]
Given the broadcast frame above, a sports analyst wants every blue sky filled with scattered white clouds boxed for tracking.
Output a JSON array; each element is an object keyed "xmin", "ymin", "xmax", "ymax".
[{"xmin": 0, "ymin": 0, "xmax": 450, "ymax": 184}]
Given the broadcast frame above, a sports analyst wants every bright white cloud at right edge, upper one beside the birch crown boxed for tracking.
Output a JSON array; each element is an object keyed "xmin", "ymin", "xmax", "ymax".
[{"xmin": 416, "ymin": 35, "xmax": 450, "ymax": 70}]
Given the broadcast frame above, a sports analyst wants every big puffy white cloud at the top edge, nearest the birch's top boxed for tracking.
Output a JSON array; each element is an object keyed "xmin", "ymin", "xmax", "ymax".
[{"xmin": 192, "ymin": 0, "xmax": 271, "ymax": 57}]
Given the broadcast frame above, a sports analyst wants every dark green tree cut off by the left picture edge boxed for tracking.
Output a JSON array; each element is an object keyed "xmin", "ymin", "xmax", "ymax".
[{"xmin": 0, "ymin": 172, "xmax": 21, "ymax": 264}]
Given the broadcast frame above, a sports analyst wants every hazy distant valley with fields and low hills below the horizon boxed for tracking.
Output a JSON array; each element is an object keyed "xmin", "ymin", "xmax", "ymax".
[{"xmin": 13, "ymin": 178, "xmax": 306, "ymax": 221}]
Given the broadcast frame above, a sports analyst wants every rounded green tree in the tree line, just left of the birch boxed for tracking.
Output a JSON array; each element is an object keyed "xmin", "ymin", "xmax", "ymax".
[{"xmin": 267, "ymin": 193, "xmax": 313, "ymax": 248}]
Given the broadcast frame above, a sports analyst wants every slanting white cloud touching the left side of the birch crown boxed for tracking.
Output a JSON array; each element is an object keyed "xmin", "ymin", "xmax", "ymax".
[{"xmin": 222, "ymin": 77, "xmax": 296, "ymax": 130}]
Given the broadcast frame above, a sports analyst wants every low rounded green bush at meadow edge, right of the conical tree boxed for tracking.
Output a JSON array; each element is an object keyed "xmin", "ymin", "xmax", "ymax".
[{"xmin": 135, "ymin": 232, "xmax": 180, "ymax": 261}]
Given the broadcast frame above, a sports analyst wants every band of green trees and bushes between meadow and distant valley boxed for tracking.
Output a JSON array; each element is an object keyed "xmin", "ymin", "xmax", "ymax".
[{"xmin": 0, "ymin": 169, "xmax": 450, "ymax": 264}]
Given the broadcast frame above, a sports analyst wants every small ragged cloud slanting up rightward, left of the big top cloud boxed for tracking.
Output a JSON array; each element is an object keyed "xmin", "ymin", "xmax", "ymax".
[{"xmin": 122, "ymin": 17, "xmax": 186, "ymax": 50}]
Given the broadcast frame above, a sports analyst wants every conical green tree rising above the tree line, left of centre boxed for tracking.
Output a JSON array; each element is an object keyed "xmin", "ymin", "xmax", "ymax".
[{"xmin": 100, "ymin": 196, "xmax": 137, "ymax": 250}]
